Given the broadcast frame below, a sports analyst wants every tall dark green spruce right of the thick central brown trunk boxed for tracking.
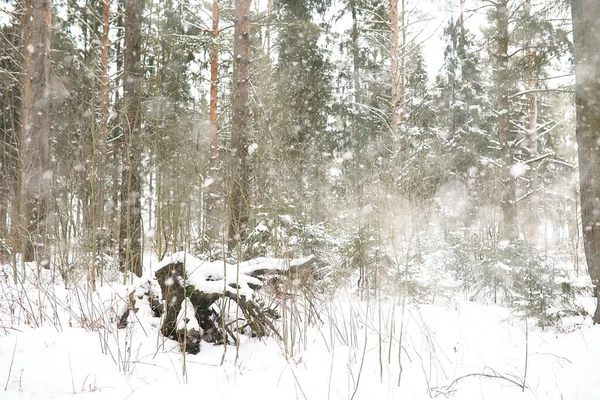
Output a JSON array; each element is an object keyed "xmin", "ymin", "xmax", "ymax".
[{"xmin": 269, "ymin": 0, "xmax": 333, "ymax": 216}]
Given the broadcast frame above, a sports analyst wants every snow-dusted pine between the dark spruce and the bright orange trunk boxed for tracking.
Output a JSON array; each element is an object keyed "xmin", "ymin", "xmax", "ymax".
[{"xmin": 330, "ymin": 0, "xmax": 396, "ymax": 207}]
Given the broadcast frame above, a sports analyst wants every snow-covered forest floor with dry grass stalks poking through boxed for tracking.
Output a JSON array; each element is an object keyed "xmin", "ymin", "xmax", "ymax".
[{"xmin": 0, "ymin": 255, "xmax": 600, "ymax": 400}]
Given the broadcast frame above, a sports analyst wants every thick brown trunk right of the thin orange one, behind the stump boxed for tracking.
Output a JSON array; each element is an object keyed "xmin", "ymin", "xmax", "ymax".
[{"xmin": 229, "ymin": 0, "xmax": 251, "ymax": 250}]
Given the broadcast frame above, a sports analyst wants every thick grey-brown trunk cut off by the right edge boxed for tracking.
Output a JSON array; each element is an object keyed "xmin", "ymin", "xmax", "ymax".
[{"xmin": 571, "ymin": 0, "xmax": 600, "ymax": 323}]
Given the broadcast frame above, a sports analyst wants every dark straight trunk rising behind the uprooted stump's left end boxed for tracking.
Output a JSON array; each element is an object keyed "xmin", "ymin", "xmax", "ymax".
[{"xmin": 119, "ymin": 0, "xmax": 143, "ymax": 276}]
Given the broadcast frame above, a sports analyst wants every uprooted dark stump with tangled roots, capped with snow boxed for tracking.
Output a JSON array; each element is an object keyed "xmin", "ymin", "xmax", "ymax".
[{"xmin": 155, "ymin": 252, "xmax": 316, "ymax": 353}]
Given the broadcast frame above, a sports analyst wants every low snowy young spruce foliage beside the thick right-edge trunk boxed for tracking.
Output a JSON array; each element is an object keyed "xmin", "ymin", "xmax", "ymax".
[{"xmin": 450, "ymin": 241, "xmax": 588, "ymax": 326}]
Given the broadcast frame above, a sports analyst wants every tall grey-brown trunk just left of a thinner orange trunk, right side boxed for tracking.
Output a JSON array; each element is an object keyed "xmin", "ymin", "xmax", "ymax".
[{"xmin": 495, "ymin": 0, "xmax": 519, "ymax": 240}]
